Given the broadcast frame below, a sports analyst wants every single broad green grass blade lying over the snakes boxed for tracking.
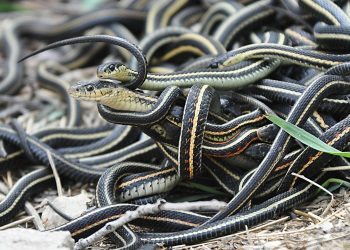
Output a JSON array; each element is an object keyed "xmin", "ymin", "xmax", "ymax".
[{"xmin": 266, "ymin": 115, "xmax": 350, "ymax": 158}]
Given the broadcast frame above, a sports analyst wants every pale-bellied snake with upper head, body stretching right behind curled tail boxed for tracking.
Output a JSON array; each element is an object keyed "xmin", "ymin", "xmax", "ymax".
[{"xmin": 97, "ymin": 32, "xmax": 285, "ymax": 90}]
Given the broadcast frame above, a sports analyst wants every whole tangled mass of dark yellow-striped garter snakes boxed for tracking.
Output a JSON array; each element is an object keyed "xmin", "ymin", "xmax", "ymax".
[{"xmin": 0, "ymin": 0, "xmax": 350, "ymax": 249}]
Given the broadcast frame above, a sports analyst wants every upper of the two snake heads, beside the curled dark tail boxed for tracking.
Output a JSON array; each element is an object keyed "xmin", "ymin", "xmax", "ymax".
[{"xmin": 97, "ymin": 62, "xmax": 137, "ymax": 82}]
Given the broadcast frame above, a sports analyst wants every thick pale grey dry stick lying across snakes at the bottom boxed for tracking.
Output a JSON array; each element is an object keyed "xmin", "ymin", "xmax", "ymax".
[{"xmin": 74, "ymin": 199, "xmax": 226, "ymax": 250}]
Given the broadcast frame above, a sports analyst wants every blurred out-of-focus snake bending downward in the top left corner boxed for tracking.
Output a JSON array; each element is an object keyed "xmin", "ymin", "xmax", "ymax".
[{"xmin": 0, "ymin": 8, "xmax": 146, "ymax": 94}]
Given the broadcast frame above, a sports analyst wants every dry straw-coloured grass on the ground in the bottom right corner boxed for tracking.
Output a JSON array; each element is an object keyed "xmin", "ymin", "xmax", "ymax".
[{"xmin": 172, "ymin": 189, "xmax": 350, "ymax": 250}]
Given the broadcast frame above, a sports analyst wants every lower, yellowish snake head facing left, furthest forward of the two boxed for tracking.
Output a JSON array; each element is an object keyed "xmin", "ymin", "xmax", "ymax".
[{"xmin": 68, "ymin": 80, "xmax": 117, "ymax": 102}]
